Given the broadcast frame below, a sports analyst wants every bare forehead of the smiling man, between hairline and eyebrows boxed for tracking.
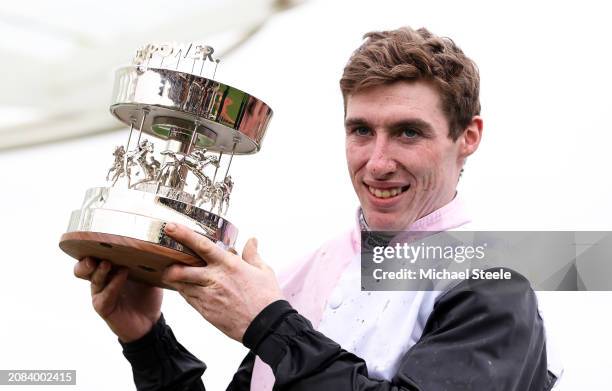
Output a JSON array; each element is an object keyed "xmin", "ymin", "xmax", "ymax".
[{"xmin": 346, "ymin": 81, "xmax": 448, "ymax": 130}]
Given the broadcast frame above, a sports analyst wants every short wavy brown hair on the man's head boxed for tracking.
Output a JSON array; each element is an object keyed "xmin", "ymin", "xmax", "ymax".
[{"xmin": 340, "ymin": 27, "xmax": 480, "ymax": 140}]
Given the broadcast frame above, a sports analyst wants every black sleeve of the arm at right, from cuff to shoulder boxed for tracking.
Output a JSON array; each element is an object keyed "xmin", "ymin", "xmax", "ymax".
[{"xmin": 243, "ymin": 274, "xmax": 554, "ymax": 391}]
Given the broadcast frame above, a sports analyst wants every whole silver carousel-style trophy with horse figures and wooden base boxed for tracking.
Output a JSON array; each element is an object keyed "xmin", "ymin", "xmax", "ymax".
[{"xmin": 59, "ymin": 44, "xmax": 272, "ymax": 286}]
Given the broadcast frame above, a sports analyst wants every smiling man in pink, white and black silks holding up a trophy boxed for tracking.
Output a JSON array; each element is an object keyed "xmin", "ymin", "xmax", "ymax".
[{"xmin": 75, "ymin": 28, "xmax": 555, "ymax": 391}]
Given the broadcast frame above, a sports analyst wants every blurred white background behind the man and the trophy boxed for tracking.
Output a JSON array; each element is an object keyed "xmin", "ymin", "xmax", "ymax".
[{"xmin": 0, "ymin": 0, "xmax": 612, "ymax": 390}]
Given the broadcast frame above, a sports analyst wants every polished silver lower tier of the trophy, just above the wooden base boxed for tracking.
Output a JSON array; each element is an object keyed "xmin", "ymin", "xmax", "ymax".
[{"xmin": 66, "ymin": 187, "xmax": 238, "ymax": 251}]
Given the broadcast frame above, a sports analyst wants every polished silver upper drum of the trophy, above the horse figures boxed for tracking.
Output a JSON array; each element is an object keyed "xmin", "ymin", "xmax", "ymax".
[{"xmin": 110, "ymin": 66, "xmax": 272, "ymax": 154}]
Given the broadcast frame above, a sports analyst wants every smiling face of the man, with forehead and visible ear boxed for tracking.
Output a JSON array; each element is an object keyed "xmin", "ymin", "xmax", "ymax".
[{"xmin": 345, "ymin": 81, "xmax": 482, "ymax": 231}]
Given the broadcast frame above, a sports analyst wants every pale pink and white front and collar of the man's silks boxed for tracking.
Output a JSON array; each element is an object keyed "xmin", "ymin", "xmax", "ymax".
[{"xmin": 251, "ymin": 196, "xmax": 470, "ymax": 391}]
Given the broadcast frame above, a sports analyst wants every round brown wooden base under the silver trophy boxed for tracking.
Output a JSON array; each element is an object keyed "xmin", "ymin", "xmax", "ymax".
[{"xmin": 59, "ymin": 232, "xmax": 205, "ymax": 289}]
